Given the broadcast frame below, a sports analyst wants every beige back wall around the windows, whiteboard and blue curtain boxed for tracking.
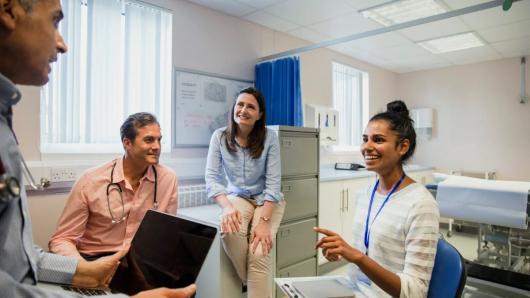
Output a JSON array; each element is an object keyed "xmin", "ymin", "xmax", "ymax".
[{"xmin": 18, "ymin": 0, "xmax": 396, "ymax": 247}]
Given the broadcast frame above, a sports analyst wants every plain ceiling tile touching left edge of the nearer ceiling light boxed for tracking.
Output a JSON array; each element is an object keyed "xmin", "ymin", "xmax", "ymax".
[{"xmin": 309, "ymin": 12, "xmax": 382, "ymax": 38}]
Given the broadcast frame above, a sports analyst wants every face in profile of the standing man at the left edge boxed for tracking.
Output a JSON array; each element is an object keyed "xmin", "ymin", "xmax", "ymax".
[{"xmin": 0, "ymin": 0, "xmax": 67, "ymax": 86}]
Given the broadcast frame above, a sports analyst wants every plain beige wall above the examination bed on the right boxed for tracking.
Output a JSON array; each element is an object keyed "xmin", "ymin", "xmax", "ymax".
[{"xmin": 397, "ymin": 58, "xmax": 530, "ymax": 181}]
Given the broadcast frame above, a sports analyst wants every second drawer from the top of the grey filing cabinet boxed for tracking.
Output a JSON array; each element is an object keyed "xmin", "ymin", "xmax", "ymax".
[{"xmin": 282, "ymin": 177, "xmax": 318, "ymax": 222}]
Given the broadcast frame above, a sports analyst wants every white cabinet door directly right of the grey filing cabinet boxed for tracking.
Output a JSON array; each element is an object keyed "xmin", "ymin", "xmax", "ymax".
[{"xmin": 318, "ymin": 181, "xmax": 345, "ymax": 265}]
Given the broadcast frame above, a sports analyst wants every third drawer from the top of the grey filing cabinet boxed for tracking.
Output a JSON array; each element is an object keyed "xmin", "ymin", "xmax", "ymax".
[{"xmin": 276, "ymin": 217, "xmax": 317, "ymax": 270}]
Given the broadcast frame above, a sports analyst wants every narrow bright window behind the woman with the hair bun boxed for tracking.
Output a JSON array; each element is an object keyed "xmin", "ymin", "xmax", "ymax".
[{"xmin": 333, "ymin": 62, "xmax": 368, "ymax": 150}]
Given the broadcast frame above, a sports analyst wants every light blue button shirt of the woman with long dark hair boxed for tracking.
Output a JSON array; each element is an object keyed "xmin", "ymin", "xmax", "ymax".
[{"xmin": 205, "ymin": 127, "xmax": 283, "ymax": 205}]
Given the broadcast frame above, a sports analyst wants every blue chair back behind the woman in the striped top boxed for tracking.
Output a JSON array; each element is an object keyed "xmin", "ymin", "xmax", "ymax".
[{"xmin": 427, "ymin": 239, "xmax": 467, "ymax": 298}]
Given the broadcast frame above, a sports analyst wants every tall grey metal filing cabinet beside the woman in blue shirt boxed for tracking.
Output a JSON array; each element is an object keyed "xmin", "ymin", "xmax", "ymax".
[{"xmin": 269, "ymin": 126, "xmax": 319, "ymax": 297}]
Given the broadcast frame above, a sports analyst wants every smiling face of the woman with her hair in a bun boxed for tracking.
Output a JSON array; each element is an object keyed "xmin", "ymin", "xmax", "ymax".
[{"xmin": 361, "ymin": 120, "xmax": 409, "ymax": 175}]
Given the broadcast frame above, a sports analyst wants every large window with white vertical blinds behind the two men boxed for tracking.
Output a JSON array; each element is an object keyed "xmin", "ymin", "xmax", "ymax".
[{"xmin": 41, "ymin": 0, "xmax": 172, "ymax": 153}]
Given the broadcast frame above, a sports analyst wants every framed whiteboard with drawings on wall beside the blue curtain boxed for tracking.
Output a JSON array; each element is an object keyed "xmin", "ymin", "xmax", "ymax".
[{"xmin": 174, "ymin": 68, "xmax": 254, "ymax": 147}]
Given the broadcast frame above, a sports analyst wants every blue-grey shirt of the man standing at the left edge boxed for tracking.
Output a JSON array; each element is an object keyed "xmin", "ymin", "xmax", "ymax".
[{"xmin": 0, "ymin": 73, "xmax": 124, "ymax": 298}]
